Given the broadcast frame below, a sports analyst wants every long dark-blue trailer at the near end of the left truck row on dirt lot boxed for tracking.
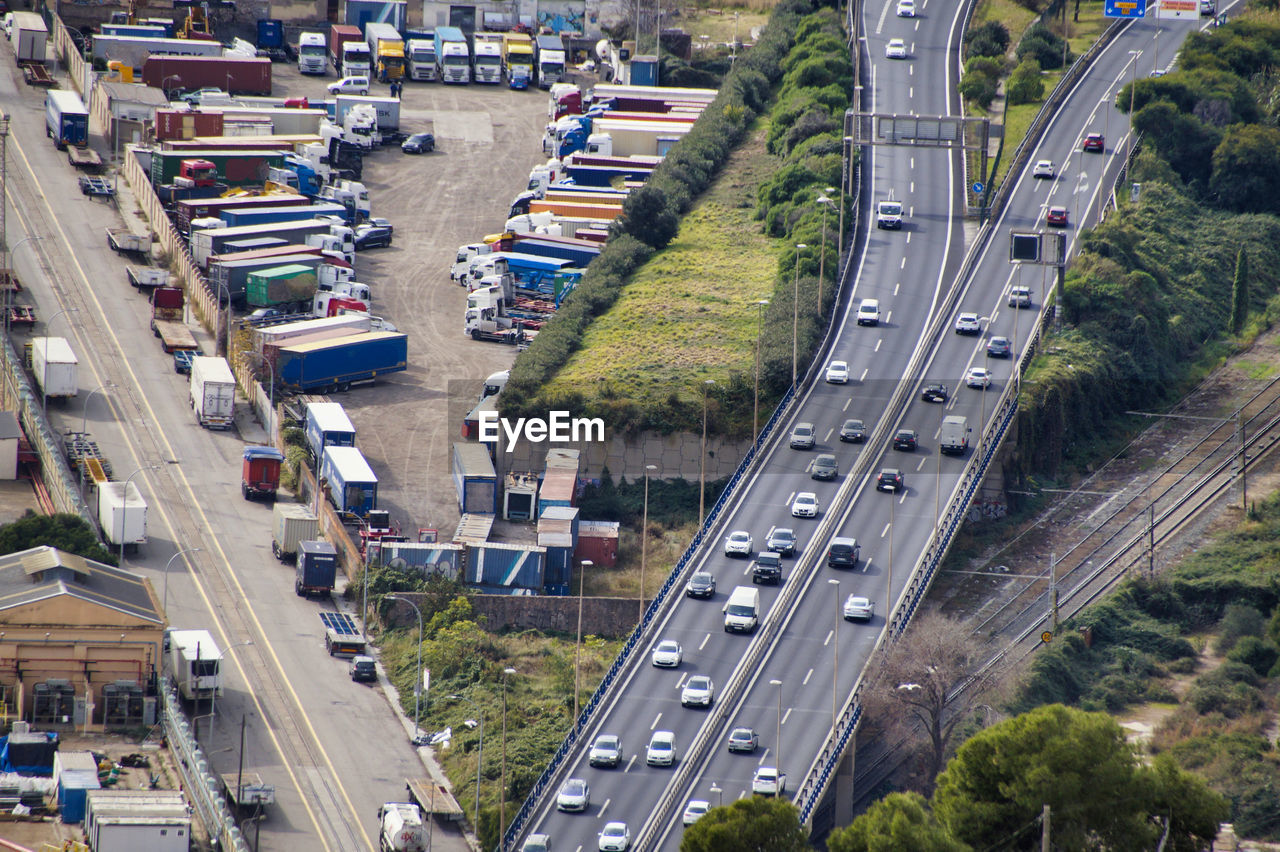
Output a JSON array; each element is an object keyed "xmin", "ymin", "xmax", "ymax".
[{"xmin": 275, "ymin": 331, "xmax": 408, "ymax": 393}]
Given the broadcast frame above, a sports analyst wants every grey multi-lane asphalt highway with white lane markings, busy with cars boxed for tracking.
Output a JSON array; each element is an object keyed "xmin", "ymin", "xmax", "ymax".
[{"xmin": 516, "ymin": 0, "xmax": 1199, "ymax": 851}]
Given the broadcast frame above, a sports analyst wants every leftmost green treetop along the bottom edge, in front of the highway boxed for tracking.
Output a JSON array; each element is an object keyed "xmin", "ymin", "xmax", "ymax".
[{"xmin": 680, "ymin": 796, "xmax": 809, "ymax": 852}]
